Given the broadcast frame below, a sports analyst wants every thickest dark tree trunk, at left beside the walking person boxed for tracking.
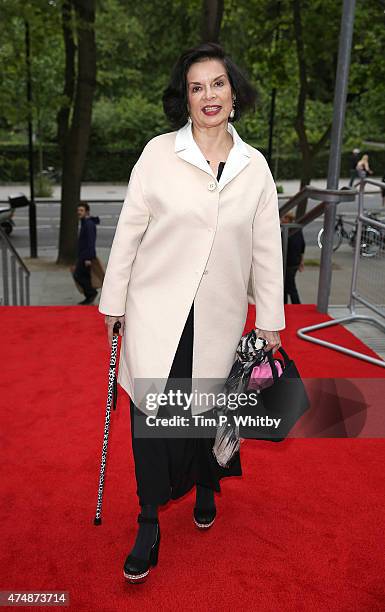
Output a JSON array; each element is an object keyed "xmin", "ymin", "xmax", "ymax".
[{"xmin": 57, "ymin": 0, "xmax": 96, "ymax": 264}]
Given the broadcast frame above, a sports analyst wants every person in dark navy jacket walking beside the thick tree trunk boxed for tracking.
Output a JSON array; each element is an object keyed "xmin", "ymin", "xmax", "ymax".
[{"xmin": 73, "ymin": 202, "xmax": 100, "ymax": 306}]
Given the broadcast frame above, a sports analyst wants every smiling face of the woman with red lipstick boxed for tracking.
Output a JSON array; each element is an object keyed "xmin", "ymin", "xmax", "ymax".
[{"xmin": 186, "ymin": 59, "xmax": 233, "ymax": 128}]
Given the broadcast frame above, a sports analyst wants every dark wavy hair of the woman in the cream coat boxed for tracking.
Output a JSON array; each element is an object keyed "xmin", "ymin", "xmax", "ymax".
[{"xmin": 162, "ymin": 43, "xmax": 257, "ymax": 129}]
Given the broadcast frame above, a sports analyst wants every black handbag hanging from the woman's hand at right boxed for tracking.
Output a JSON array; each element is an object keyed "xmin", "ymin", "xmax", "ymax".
[{"xmin": 239, "ymin": 347, "xmax": 310, "ymax": 442}]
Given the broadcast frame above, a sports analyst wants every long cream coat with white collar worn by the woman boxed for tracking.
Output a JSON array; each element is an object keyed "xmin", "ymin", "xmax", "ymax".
[{"xmin": 99, "ymin": 123, "xmax": 285, "ymax": 414}]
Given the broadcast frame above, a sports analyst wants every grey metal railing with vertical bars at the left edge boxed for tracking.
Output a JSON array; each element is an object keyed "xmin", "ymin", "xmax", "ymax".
[{"xmin": 0, "ymin": 227, "xmax": 31, "ymax": 306}]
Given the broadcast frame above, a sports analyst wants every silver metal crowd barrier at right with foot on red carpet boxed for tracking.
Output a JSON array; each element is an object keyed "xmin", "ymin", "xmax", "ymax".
[{"xmin": 297, "ymin": 178, "xmax": 385, "ymax": 368}]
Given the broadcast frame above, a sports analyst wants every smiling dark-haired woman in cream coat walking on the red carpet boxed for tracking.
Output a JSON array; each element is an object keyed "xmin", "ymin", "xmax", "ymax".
[{"xmin": 99, "ymin": 43, "xmax": 285, "ymax": 582}]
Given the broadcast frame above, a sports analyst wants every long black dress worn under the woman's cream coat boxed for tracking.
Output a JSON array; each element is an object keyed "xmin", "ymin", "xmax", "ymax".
[{"xmin": 130, "ymin": 162, "xmax": 242, "ymax": 506}]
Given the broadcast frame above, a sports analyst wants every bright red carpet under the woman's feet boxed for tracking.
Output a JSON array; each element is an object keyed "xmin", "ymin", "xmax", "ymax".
[{"xmin": 0, "ymin": 305, "xmax": 385, "ymax": 612}]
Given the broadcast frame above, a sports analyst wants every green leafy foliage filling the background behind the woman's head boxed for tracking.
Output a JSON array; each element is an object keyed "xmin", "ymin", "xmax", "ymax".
[{"xmin": 0, "ymin": 0, "xmax": 385, "ymax": 180}]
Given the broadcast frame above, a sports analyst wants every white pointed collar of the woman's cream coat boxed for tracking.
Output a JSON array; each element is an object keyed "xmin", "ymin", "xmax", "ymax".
[{"xmin": 175, "ymin": 121, "xmax": 251, "ymax": 191}]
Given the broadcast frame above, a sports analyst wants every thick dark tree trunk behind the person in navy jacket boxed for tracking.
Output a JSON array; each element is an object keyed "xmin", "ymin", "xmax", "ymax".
[{"xmin": 57, "ymin": 0, "xmax": 96, "ymax": 264}]
